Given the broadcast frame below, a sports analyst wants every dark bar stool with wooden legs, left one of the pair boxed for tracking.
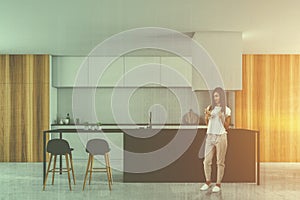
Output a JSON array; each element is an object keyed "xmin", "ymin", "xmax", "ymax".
[{"xmin": 43, "ymin": 139, "xmax": 75, "ymax": 190}]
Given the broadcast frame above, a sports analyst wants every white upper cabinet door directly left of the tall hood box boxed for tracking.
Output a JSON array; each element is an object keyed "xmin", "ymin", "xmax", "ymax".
[{"xmin": 161, "ymin": 57, "xmax": 192, "ymax": 87}]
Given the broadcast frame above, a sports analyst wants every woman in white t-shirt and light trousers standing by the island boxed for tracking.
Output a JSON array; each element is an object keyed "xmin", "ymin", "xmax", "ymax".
[{"xmin": 200, "ymin": 87, "xmax": 231, "ymax": 192}]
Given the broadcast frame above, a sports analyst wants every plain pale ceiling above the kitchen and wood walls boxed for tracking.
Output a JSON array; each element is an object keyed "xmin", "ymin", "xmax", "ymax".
[{"xmin": 0, "ymin": 0, "xmax": 300, "ymax": 55}]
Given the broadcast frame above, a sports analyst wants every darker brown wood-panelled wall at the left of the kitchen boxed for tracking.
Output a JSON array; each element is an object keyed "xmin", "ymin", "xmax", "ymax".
[{"xmin": 0, "ymin": 55, "xmax": 49, "ymax": 162}]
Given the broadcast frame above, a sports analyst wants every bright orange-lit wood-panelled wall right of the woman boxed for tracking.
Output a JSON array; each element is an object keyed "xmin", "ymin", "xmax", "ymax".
[{"xmin": 235, "ymin": 55, "xmax": 300, "ymax": 162}]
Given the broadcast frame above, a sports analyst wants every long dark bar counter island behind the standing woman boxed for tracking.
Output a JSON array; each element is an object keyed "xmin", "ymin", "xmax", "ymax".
[{"xmin": 43, "ymin": 126, "xmax": 260, "ymax": 185}]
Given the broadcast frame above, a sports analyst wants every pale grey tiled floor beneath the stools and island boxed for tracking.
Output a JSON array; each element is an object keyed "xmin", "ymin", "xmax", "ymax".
[{"xmin": 0, "ymin": 162, "xmax": 300, "ymax": 200}]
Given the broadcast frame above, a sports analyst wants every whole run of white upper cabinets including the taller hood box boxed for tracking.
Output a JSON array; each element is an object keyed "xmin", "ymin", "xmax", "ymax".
[{"xmin": 52, "ymin": 32, "xmax": 242, "ymax": 90}]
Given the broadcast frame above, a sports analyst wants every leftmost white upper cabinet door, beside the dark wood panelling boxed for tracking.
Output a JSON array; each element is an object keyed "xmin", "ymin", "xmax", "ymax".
[{"xmin": 52, "ymin": 57, "xmax": 88, "ymax": 87}]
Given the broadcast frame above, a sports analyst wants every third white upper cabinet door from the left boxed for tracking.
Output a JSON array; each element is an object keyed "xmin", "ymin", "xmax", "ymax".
[{"xmin": 124, "ymin": 57, "xmax": 160, "ymax": 87}]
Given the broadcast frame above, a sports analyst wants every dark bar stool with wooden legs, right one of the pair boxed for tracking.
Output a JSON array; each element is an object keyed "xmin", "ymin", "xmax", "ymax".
[{"xmin": 82, "ymin": 139, "xmax": 112, "ymax": 190}]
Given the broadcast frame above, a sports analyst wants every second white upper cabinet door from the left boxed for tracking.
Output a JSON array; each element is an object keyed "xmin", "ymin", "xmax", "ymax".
[{"xmin": 89, "ymin": 57, "xmax": 124, "ymax": 87}]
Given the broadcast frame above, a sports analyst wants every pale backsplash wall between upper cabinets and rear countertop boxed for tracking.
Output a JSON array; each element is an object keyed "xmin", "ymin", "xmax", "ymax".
[{"xmin": 52, "ymin": 87, "xmax": 234, "ymax": 124}]
